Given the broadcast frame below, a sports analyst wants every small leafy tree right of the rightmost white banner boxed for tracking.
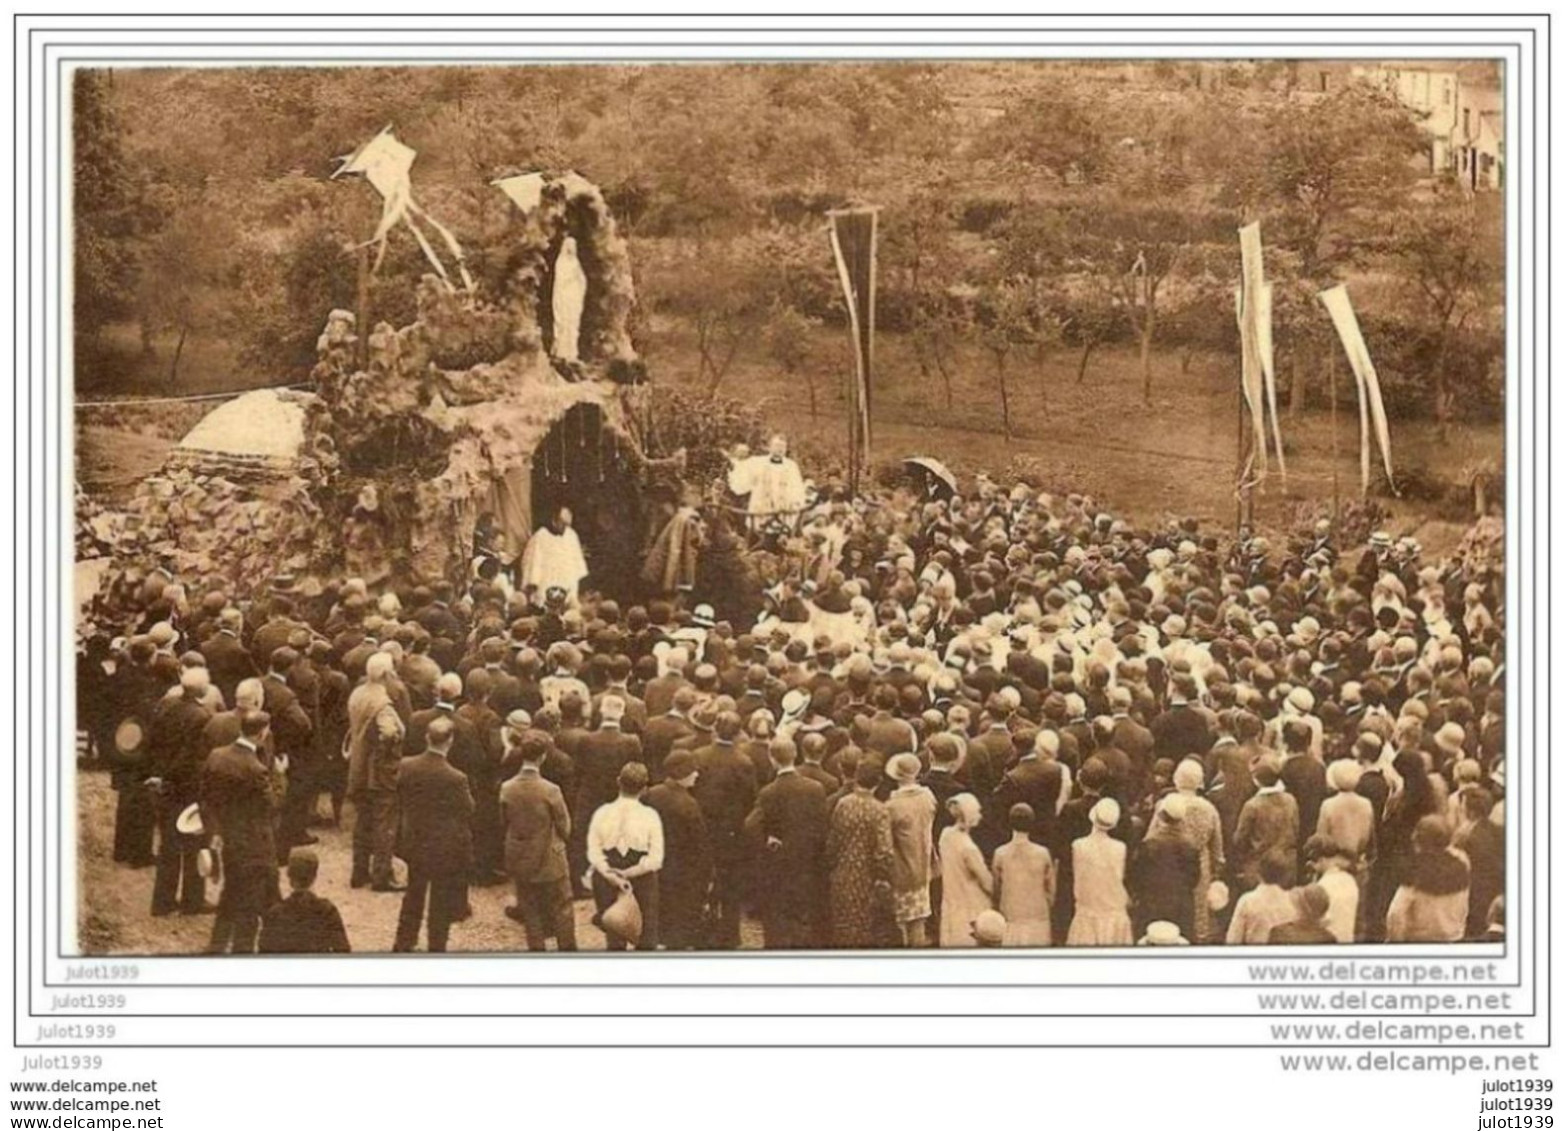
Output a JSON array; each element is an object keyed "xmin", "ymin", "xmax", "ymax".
[{"xmin": 1389, "ymin": 188, "xmax": 1503, "ymax": 435}]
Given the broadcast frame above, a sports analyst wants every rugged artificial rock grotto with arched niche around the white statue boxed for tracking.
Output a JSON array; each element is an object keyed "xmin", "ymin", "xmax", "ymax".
[{"xmin": 100, "ymin": 172, "xmax": 672, "ymax": 600}]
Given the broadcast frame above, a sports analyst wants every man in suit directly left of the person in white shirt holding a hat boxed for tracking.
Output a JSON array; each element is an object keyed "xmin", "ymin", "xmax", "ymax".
[{"xmin": 499, "ymin": 731, "xmax": 576, "ymax": 951}]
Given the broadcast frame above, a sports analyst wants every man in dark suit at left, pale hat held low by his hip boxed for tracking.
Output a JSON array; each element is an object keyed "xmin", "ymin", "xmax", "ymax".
[{"xmin": 149, "ymin": 668, "xmax": 211, "ymax": 915}]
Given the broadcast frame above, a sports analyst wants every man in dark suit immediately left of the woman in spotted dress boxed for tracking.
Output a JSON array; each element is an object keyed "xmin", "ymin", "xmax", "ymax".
[{"xmin": 744, "ymin": 738, "xmax": 826, "ymax": 950}]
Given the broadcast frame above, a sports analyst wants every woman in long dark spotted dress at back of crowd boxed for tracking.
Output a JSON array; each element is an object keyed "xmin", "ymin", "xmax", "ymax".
[{"xmin": 826, "ymin": 759, "xmax": 891, "ymax": 946}]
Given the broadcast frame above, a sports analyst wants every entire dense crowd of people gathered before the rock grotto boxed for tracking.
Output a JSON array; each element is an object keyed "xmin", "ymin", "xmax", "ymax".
[{"xmin": 78, "ymin": 450, "xmax": 1505, "ymax": 953}]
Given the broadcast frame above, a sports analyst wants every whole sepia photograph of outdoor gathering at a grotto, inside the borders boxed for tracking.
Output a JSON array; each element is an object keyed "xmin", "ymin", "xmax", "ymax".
[{"xmin": 63, "ymin": 56, "xmax": 1519, "ymax": 957}]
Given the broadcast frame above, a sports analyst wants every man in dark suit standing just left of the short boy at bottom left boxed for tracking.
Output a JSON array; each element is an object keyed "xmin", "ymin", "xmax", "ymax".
[{"xmin": 200, "ymin": 710, "xmax": 285, "ymax": 954}]
